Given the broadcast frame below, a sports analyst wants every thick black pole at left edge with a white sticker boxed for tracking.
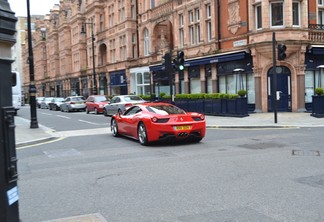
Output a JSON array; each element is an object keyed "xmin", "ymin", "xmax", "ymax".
[{"xmin": 0, "ymin": 0, "xmax": 19, "ymax": 222}]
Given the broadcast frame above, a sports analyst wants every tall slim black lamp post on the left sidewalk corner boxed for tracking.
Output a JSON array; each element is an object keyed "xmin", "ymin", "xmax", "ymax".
[{"xmin": 27, "ymin": 0, "xmax": 38, "ymax": 128}]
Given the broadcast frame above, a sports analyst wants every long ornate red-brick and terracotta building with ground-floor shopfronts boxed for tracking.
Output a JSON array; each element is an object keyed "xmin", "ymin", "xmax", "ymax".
[{"xmin": 20, "ymin": 0, "xmax": 324, "ymax": 112}]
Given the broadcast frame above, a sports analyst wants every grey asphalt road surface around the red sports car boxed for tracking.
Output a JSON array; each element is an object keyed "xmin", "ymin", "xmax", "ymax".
[{"xmin": 17, "ymin": 106, "xmax": 324, "ymax": 222}]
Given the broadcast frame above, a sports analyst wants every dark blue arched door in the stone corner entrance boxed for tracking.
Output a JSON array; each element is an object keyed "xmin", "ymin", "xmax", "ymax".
[{"xmin": 268, "ymin": 66, "xmax": 291, "ymax": 112}]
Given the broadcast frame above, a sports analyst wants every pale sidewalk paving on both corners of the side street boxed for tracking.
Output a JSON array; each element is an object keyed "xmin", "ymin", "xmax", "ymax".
[{"xmin": 15, "ymin": 113, "xmax": 324, "ymax": 147}]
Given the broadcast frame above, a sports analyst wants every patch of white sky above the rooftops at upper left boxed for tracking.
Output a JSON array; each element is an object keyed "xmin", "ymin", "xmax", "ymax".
[{"xmin": 8, "ymin": 0, "xmax": 60, "ymax": 17}]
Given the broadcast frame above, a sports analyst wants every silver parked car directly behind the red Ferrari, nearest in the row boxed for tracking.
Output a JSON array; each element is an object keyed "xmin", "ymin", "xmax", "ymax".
[{"xmin": 104, "ymin": 95, "xmax": 146, "ymax": 116}]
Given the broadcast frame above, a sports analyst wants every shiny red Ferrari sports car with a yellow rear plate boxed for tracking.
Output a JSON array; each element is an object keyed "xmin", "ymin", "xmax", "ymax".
[{"xmin": 111, "ymin": 102, "xmax": 206, "ymax": 145}]
